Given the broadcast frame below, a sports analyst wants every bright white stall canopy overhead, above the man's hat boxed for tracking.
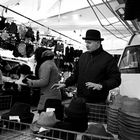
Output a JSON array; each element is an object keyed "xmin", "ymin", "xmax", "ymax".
[{"xmin": 0, "ymin": 0, "xmax": 139, "ymax": 50}]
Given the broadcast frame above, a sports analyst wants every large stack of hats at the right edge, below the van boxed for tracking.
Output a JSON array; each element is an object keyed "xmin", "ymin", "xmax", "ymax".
[{"xmin": 118, "ymin": 98, "xmax": 140, "ymax": 140}]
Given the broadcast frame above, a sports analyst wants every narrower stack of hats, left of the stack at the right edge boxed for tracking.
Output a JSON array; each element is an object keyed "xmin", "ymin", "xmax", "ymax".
[{"xmin": 107, "ymin": 94, "xmax": 123, "ymax": 134}]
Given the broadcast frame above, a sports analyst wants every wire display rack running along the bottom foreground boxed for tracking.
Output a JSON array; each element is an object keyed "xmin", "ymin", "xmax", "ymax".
[{"xmin": 0, "ymin": 120, "xmax": 114, "ymax": 140}]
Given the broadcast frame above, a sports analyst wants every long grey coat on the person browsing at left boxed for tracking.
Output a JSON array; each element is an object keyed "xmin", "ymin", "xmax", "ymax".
[{"xmin": 33, "ymin": 60, "xmax": 61, "ymax": 110}]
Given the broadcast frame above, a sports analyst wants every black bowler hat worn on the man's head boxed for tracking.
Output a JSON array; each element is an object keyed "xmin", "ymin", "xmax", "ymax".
[{"xmin": 83, "ymin": 29, "xmax": 104, "ymax": 41}]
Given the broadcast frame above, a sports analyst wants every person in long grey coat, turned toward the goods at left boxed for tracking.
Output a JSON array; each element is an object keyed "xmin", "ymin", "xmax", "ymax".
[{"xmin": 26, "ymin": 47, "xmax": 63, "ymax": 120}]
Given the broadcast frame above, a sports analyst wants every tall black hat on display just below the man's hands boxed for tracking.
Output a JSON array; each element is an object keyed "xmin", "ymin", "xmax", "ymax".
[{"xmin": 65, "ymin": 97, "xmax": 88, "ymax": 118}]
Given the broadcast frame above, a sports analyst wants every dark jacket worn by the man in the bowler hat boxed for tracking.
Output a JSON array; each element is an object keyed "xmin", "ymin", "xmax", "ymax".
[{"xmin": 65, "ymin": 46, "xmax": 121, "ymax": 103}]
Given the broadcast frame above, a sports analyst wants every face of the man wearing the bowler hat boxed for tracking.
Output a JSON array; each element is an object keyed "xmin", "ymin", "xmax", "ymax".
[{"xmin": 85, "ymin": 40, "xmax": 100, "ymax": 52}]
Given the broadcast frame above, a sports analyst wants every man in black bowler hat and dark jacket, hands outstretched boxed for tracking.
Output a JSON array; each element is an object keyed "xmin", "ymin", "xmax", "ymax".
[{"xmin": 52, "ymin": 29, "xmax": 121, "ymax": 104}]
